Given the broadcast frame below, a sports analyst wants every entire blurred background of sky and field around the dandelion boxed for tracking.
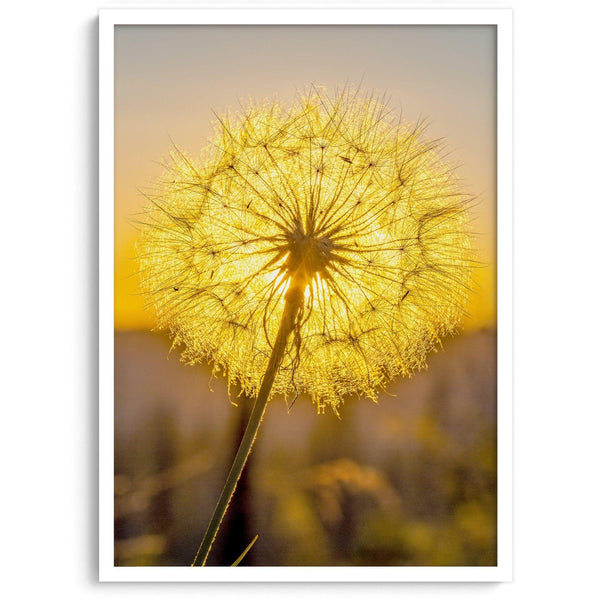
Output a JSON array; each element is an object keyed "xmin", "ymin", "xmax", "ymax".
[{"xmin": 115, "ymin": 26, "xmax": 497, "ymax": 566}]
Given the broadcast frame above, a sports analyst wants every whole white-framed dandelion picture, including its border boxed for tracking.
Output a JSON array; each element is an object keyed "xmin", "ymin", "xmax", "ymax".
[{"xmin": 99, "ymin": 8, "xmax": 512, "ymax": 582}]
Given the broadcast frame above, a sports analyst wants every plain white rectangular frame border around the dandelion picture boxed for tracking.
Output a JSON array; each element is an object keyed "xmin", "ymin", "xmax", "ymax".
[{"xmin": 98, "ymin": 5, "xmax": 513, "ymax": 583}]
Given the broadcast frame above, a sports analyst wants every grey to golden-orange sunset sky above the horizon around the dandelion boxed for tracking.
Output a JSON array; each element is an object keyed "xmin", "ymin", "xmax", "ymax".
[{"xmin": 115, "ymin": 25, "xmax": 496, "ymax": 329}]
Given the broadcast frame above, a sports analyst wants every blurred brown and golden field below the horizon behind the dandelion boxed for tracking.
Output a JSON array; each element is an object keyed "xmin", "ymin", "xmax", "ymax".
[{"xmin": 115, "ymin": 329, "xmax": 496, "ymax": 566}]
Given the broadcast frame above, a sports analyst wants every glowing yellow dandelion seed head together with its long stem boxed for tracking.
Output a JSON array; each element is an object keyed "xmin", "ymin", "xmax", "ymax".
[{"xmin": 139, "ymin": 88, "xmax": 472, "ymax": 564}]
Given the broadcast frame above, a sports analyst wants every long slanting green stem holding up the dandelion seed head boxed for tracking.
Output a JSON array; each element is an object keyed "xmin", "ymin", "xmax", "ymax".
[{"xmin": 191, "ymin": 281, "xmax": 304, "ymax": 567}]
